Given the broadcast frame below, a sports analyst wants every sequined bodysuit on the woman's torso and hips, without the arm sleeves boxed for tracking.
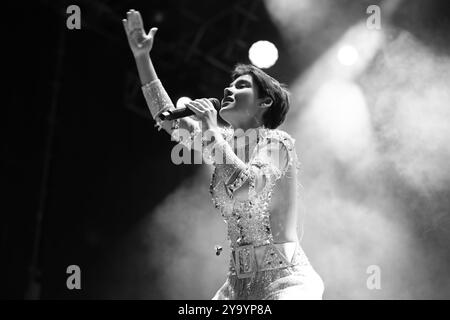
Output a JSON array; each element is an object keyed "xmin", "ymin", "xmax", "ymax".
[{"xmin": 210, "ymin": 128, "xmax": 323, "ymax": 300}]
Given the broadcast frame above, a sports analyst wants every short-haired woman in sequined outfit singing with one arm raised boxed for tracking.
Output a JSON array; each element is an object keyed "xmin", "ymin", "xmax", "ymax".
[{"xmin": 123, "ymin": 10, "xmax": 324, "ymax": 300}]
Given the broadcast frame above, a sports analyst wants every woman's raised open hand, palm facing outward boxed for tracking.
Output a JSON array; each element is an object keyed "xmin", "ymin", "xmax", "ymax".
[{"xmin": 122, "ymin": 9, "xmax": 158, "ymax": 57}]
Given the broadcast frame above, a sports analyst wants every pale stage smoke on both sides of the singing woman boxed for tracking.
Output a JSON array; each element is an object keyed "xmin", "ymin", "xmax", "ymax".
[{"xmin": 125, "ymin": 29, "xmax": 450, "ymax": 299}]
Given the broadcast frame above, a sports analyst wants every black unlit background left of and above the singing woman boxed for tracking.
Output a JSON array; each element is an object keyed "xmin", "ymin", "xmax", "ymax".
[{"xmin": 0, "ymin": 0, "xmax": 450, "ymax": 299}]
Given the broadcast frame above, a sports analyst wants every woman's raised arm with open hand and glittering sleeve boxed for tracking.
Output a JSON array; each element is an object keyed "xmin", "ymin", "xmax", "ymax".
[{"xmin": 122, "ymin": 10, "xmax": 200, "ymax": 147}]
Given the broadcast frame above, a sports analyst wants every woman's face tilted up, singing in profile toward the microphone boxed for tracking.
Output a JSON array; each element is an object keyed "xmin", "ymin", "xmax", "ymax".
[{"xmin": 219, "ymin": 74, "xmax": 263, "ymax": 128}]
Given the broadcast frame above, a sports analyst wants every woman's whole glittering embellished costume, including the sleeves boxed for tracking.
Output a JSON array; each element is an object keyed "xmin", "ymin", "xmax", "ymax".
[{"xmin": 143, "ymin": 79, "xmax": 324, "ymax": 300}]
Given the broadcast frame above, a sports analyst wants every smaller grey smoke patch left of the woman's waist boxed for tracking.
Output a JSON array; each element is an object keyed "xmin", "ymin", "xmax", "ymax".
[{"xmin": 141, "ymin": 165, "xmax": 229, "ymax": 299}]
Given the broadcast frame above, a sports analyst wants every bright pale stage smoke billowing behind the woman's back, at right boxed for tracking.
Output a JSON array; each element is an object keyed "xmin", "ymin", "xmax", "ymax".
[{"xmin": 290, "ymin": 32, "xmax": 450, "ymax": 299}]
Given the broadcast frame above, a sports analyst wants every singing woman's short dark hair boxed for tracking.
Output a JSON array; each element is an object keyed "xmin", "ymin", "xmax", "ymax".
[{"xmin": 231, "ymin": 64, "xmax": 290, "ymax": 129}]
